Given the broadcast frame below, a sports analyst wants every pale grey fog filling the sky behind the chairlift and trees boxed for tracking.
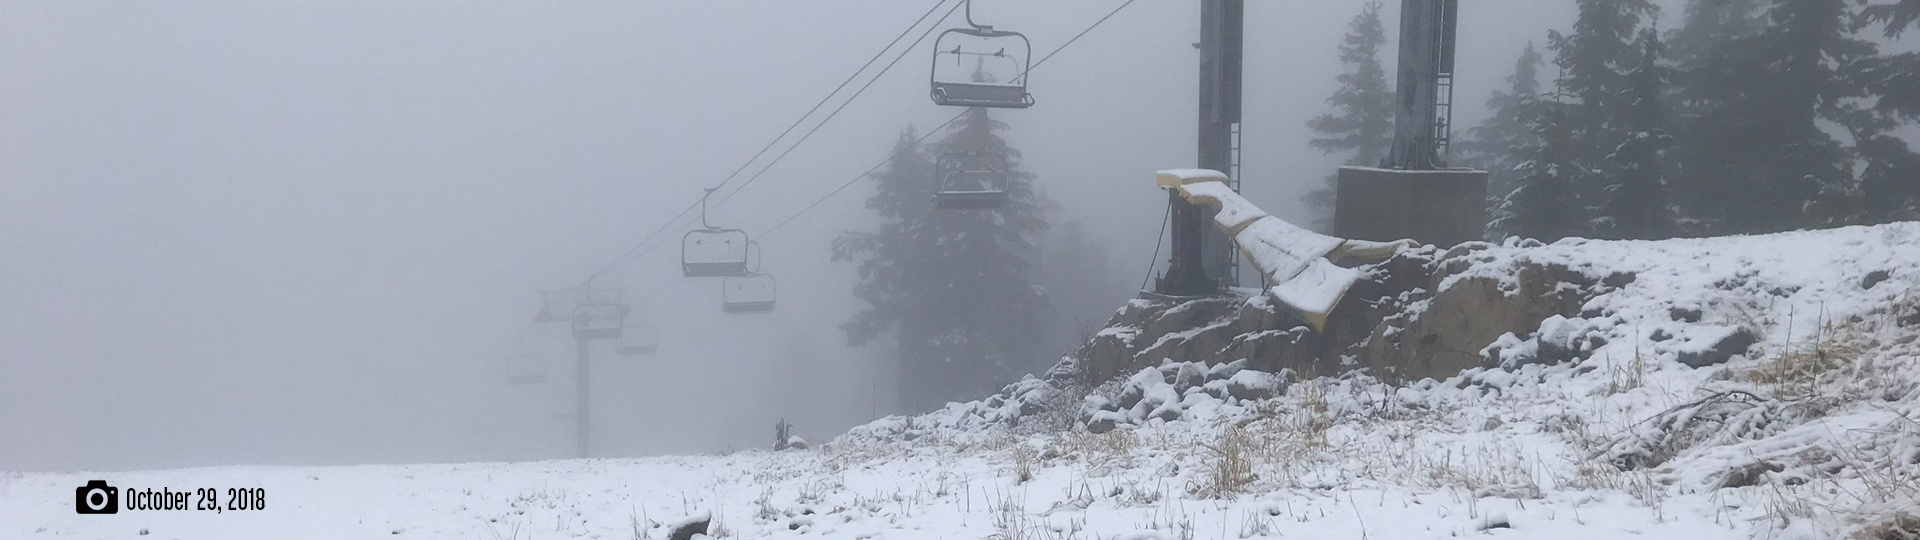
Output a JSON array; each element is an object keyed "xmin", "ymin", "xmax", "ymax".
[{"xmin": 0, "ymin": 0, "xmax": 1574, "ymax": 471}]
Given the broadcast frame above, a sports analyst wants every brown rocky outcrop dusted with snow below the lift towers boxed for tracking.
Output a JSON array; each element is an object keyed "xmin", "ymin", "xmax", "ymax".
[{"xmin": 1075, "ymin": 242, "xmax": 1634, "ymax": 384}]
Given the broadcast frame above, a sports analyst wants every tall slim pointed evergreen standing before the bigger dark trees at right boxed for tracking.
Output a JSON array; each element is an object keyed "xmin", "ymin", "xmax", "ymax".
[{"xmin": 1596, "ymin": 29, "xmax": 1672, "ymax": 240}]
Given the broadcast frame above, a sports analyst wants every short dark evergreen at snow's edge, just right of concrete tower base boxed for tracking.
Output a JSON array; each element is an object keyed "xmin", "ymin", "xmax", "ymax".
[{"xmin": 1490, "ymin": 98, "xmax": 1588, "ymax": 242}]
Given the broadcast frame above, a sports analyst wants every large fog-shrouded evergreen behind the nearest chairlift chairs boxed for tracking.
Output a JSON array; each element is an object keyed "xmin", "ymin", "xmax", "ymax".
[{"xmin": 833, "ymin": 108, "xmax": 1046, "ymax": 409}]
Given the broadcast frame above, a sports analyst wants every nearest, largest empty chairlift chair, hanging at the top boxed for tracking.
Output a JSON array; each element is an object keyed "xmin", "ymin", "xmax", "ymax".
[{"xmin": 929, "ymin": 2, "xmax": 1033, "ymax": 110}]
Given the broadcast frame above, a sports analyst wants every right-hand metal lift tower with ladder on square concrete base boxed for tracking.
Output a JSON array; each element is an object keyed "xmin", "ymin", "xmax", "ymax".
[{"xmin": 1334, "ymin": 0, "xmax": 1486, "ymax": 246}]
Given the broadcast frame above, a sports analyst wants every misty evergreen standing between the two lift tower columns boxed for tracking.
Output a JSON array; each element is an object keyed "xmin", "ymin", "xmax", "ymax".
[{"xmin": 1302, "ymin": 0, "xmax": 1394, "ymax": 231}]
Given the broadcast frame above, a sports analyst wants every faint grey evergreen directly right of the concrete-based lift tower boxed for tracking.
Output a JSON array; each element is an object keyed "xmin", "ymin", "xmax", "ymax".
[{"xmin": 1459, "ymin": 42, "xmax": 1546, "ymax": 216}]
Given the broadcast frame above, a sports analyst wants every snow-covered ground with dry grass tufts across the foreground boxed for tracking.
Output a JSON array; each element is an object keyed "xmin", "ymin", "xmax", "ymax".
[{"xmin": 11, "ymin": 223, "xmax": 1920, "ymax": 540}]
